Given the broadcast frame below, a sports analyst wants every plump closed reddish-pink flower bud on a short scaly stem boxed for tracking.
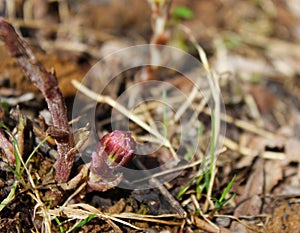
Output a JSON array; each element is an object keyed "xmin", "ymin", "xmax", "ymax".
[{"xmin": 88, "ymin": 130, "xmax": 136, "ymax": 191}]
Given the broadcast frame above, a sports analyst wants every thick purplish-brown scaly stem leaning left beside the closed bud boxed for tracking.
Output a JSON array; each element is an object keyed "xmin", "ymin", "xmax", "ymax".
[{"xmin": 0, "ymin": 18, "xmax": 74, "ymax": 183}]
